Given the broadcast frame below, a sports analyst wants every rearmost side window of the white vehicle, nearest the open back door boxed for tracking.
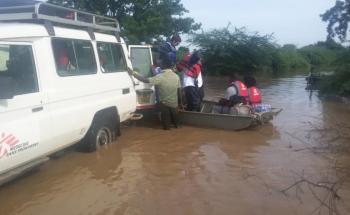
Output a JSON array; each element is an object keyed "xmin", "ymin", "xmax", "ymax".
[{"xmin": 97, "ymin": 42, "xmax": 126, "ymax": 73}]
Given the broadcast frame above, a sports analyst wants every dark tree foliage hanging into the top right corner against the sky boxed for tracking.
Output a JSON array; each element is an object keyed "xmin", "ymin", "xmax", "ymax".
[{"xmin": 321, "ymin": 0, "xmax": 350, "ymax": 42}]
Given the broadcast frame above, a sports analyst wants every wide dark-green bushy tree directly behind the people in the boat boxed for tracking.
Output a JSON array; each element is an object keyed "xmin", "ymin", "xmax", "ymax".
[{"xmin": 191, "ymin": 28, "xmax": 284, "ymax": 75}]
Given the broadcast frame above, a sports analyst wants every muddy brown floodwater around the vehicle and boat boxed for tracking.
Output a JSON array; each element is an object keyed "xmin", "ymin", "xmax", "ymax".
[{"xmin": 0, "ymin": 77, "xmax": 350, "ymax": 215}]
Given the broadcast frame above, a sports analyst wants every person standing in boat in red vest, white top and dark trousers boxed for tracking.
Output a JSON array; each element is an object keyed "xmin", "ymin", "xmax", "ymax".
[{"xmin": 177, "ymin": 51, "xmax": 204, "ymax": 112}]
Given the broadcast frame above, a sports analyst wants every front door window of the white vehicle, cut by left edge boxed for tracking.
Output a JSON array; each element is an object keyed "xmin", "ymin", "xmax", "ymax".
[{"xmin": 0, "ymin": 45, "xmax": 39, "ymax": 95}]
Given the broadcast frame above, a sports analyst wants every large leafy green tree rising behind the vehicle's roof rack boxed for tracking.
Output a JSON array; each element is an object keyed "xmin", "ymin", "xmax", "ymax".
[{"xmin": 49, "ymin": 0, "xmax": 201, "ymax": 43}]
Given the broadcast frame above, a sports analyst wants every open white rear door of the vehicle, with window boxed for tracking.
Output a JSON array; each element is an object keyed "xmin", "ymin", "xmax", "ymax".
[{"xmin": 129, "ymin": 45, "xmax": 156, "ymax": 110}]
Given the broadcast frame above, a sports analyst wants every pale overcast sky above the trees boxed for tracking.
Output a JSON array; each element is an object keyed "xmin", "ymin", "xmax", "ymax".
[{"xmin": 182, "ymin": 0, "xmax": 335, "ymax": 47}]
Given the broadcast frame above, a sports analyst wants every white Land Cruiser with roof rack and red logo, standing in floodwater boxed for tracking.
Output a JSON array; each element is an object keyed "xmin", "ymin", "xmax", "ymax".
[{"xmin": 0, "ymin": 3, "xmax": 137, "ymax": 184}]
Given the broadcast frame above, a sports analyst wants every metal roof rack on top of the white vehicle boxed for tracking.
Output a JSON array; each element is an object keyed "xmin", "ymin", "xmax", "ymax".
[{"xmin": 0, "ymin": 2, "xmax": 120, "ymax": 35}]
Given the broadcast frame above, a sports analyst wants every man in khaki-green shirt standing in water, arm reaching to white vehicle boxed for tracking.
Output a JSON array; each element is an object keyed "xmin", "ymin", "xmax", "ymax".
[{"xmin": 128, "ymin": 54, "xmax": 181, "ymax": 130}]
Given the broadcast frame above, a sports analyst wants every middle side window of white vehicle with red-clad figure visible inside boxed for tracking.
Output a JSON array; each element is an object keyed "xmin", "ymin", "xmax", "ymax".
[{"xmin": 52, "ymin": 38, "xmax": 97, "ymax": 76}]
